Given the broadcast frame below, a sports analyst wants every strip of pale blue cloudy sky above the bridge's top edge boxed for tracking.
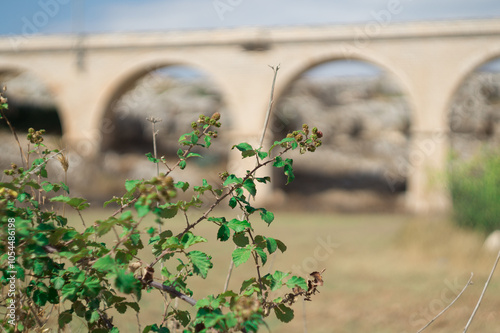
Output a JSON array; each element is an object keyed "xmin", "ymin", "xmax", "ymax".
[{"xmin": 0, "ymin": 0, "xmax": 500, "ymax": 35}]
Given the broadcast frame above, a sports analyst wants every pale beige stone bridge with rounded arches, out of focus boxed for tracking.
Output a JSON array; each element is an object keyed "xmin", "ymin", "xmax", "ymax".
[{"xmin": 0, "ymin": 20, "xmax": 500, "ymax": 212}]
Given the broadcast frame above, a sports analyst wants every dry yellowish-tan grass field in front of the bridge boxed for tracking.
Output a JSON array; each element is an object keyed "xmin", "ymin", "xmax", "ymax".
[{"xmin": 62, "ymin": 211, "xmax": 500, "ymax": 333}]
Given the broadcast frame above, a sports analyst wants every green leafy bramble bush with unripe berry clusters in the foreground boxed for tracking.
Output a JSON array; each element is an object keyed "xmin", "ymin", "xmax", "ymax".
[{"xmin": 0, "ymin": 76, "xmax": 323, "ymax": 333}]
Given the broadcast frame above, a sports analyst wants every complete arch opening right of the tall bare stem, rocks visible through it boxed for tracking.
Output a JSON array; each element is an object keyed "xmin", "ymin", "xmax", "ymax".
[{"xmin": 274, "ymin": 53, "xmax": 412, "ymax": 210}]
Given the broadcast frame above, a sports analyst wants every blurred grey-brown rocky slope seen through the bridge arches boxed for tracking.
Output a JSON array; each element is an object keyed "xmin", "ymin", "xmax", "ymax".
[{"xmin": 0, "ymin": 68, "xmax": 500, "ymax": 211}]
